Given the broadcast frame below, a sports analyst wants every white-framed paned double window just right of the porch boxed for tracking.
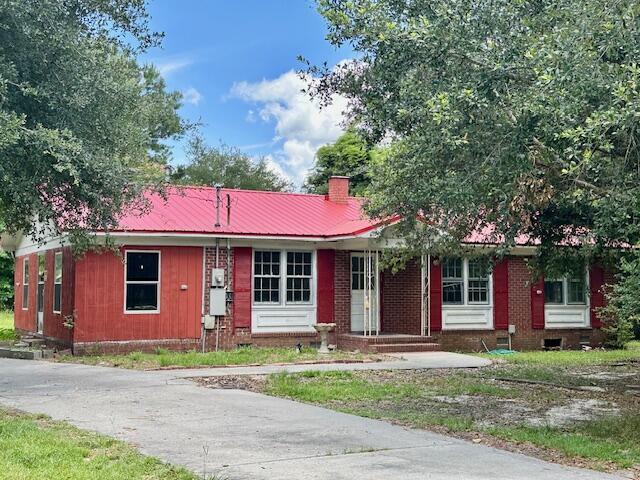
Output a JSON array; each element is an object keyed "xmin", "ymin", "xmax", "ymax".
[{"xmin": 442, "ymin": 258, "xmax": 490, "ymax": 305}]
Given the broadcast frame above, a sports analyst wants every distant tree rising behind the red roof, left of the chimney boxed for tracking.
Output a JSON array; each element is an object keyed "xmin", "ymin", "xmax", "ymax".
[{"xmin": 171, "ymin": 136, "xmax": 291, "ymax": 192}]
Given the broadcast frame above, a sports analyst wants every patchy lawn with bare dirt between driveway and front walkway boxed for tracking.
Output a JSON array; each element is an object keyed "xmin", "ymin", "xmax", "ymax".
[{"xmin": 200, "ymin": 342, "xmax": 640, "ymax": 477}]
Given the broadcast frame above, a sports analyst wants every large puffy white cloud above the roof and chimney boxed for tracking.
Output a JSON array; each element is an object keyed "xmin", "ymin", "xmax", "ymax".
[{"xmin": 231, "ymin": 71, "xmax": 347, "ymax": 184}]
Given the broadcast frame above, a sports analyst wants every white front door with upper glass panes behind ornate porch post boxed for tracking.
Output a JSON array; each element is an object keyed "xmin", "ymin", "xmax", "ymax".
[{"xmin": 351, "ymin": 253, "xmax": 379, "ymax": 333}]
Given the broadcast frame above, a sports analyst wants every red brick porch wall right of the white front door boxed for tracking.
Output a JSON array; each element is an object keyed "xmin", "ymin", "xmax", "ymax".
[{"xmin": 382, "ymin": 259, "xmax": 422, "ymax": 335}]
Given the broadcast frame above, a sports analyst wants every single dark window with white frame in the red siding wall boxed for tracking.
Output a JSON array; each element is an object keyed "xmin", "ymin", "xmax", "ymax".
[{"xmin": 125, "ymin": 251, "xmax": 160, "ymax": 313}]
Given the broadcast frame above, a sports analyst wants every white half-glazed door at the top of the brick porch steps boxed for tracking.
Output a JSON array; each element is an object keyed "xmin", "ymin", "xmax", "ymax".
[{"xmin": 351, "ymin": 253, "xmax": 378, "ymax": 332}]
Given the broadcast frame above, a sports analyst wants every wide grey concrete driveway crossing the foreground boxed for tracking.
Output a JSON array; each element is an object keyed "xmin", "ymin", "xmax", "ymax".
[{"xmin": 0, "ymin": 359, "xmax": 617, "ymax": 480}]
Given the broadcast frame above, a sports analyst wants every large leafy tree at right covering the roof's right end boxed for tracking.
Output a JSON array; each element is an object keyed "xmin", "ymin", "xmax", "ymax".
[{"xmin": 310, "ymin": 0, "xmax": 640, "ymax": 261}]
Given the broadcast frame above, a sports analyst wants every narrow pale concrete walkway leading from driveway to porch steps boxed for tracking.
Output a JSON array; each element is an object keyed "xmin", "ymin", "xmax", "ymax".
[{"xmin": 155, "ymin": 352, "xmax": 491, "ymax": 378}]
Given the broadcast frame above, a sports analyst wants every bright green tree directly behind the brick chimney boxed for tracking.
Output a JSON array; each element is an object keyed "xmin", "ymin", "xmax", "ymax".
[{"xmin": 304, "ymin": 130, "xmax": 374, "ymax": 196}]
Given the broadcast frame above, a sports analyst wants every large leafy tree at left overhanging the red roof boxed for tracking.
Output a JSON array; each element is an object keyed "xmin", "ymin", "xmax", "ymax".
[{"xmin": 0, "ymin": 0, "xmax": 186, "ymax": 246}]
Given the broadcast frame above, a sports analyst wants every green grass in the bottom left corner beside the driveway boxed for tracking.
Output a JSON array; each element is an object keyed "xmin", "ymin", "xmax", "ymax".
[{"xmin": 0, "ymin": 409, "xmax": 198, "ymax": 480}]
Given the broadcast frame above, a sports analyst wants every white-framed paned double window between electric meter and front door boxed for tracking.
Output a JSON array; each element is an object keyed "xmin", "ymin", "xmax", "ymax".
[{"xmin": 253, "ymin": 250, "xmax": 313, "ymax": 305}]
